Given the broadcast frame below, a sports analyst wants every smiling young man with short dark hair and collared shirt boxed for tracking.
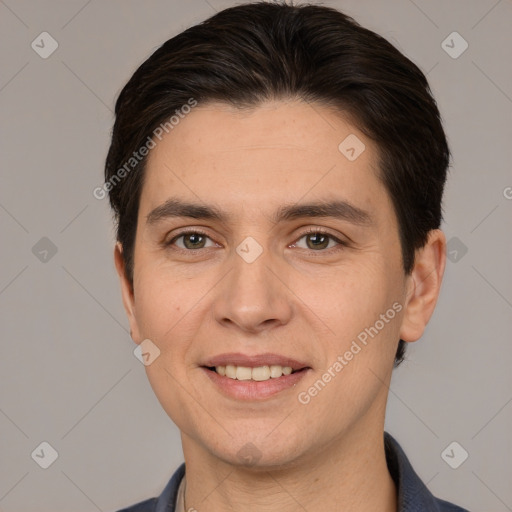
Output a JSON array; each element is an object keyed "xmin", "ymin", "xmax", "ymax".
[{"xmin": 105, "ymin": 3, "xmax": 472, "ymax": 512}]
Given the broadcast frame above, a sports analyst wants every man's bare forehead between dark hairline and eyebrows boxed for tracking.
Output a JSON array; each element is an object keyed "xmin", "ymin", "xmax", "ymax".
[{"xmin": 141, "ymin": 101, "xmax": 388, "ymax": 221}]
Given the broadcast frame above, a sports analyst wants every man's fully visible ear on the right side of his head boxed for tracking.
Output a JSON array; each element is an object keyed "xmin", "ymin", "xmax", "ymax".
[{"xmin": 400, "ymin": 229, "xmax": 446, "ymax": 342}]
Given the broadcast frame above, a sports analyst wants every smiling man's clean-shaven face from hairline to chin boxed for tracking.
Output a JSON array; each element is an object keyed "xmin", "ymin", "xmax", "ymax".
[{"xmin": 116, "ymin": 102, "xmax": 440, "ymax": 467}]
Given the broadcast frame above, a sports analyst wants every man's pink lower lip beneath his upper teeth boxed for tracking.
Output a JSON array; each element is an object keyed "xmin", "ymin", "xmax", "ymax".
[{"xmin": 202, "ymin": 367, "xmax": 310, "ymax": 400}]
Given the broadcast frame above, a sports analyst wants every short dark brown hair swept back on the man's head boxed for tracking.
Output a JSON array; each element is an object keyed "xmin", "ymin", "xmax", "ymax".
[{"xmin": 105, "ymin": 2, "xmax": 450, "ymax": 366}]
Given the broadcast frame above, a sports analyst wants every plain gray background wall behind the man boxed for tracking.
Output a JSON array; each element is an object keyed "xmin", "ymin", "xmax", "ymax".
[{"xmin": 0, "ymin": 0, "xmax": 512, "ymax": 512}]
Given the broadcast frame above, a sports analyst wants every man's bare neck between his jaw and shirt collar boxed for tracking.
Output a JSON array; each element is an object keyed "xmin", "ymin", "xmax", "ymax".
[{"xmin": 182, "ymin": 425, "xmax": 397, "ymax": 512}]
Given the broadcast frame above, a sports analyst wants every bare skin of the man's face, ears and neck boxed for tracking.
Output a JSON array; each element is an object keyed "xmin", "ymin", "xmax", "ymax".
[{"xmin": 115, "ymin": 100, "xmax": 446, "ymax": 512}]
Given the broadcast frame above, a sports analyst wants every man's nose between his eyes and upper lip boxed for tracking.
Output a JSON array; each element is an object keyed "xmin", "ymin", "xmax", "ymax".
[{"xmin": 213, "ymin": 241, "xmax": 293, "ymax": 333}]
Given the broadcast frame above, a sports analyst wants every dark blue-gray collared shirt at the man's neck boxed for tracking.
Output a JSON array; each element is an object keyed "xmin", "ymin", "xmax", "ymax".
[{"xmin": 118, "ymin": 432, "xmax": 469, "ymax": 512}]
